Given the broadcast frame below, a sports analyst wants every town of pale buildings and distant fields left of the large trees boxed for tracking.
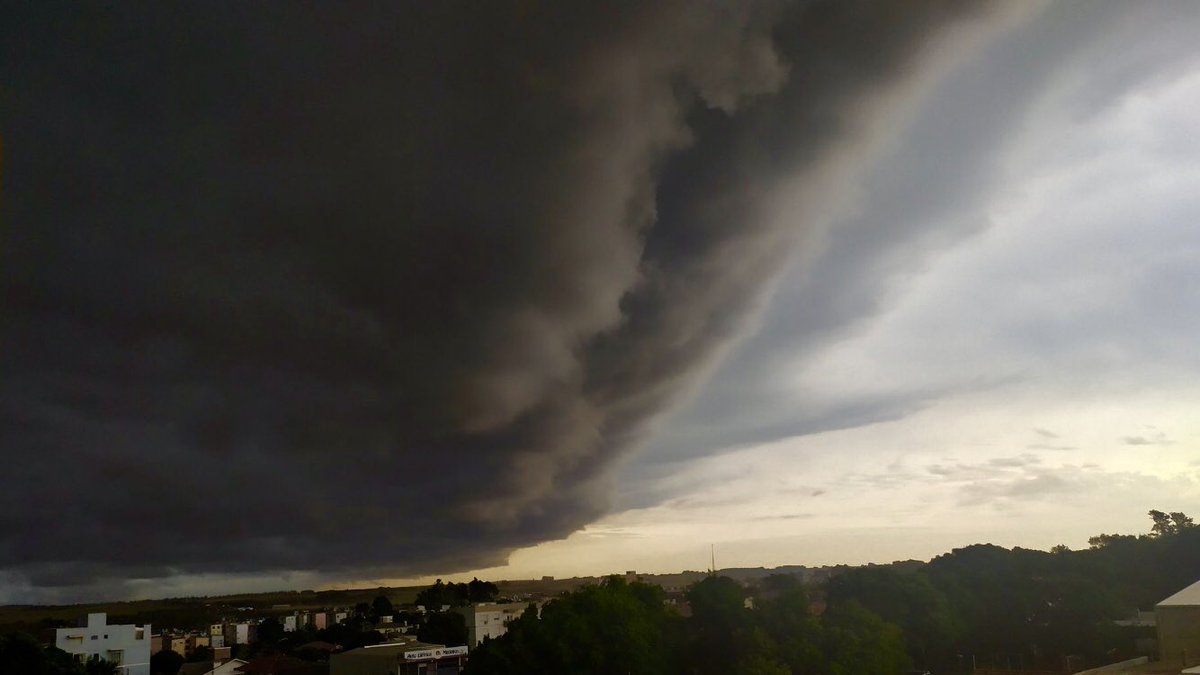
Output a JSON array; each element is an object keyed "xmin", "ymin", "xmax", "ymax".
[{"xmin": 0, "ymin": 562, "xmax": 840, "ymax": 675}]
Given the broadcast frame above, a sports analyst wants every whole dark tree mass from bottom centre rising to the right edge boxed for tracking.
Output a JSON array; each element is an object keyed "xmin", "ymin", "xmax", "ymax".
[{"xmin": 468, "ymin": 510, "xmax": 1200, "ymax": 675}]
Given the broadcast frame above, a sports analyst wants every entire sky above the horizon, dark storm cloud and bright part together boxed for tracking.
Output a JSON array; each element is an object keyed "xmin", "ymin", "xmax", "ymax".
[{"xmin": 0, "ymin": 0, "xmax": 1200, "ymax": 603}]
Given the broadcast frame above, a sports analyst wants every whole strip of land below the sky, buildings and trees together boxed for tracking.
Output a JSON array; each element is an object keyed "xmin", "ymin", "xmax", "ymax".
[{"xmin": 7, "ymin": 510, "xmax": 1200, "ymax": 675}]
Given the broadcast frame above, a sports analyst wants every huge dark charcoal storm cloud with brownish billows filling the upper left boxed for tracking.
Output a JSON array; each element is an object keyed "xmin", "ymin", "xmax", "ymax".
[{"xmin": 0, "ymin": 1, "xmax": 993, "ymax": 598}]
